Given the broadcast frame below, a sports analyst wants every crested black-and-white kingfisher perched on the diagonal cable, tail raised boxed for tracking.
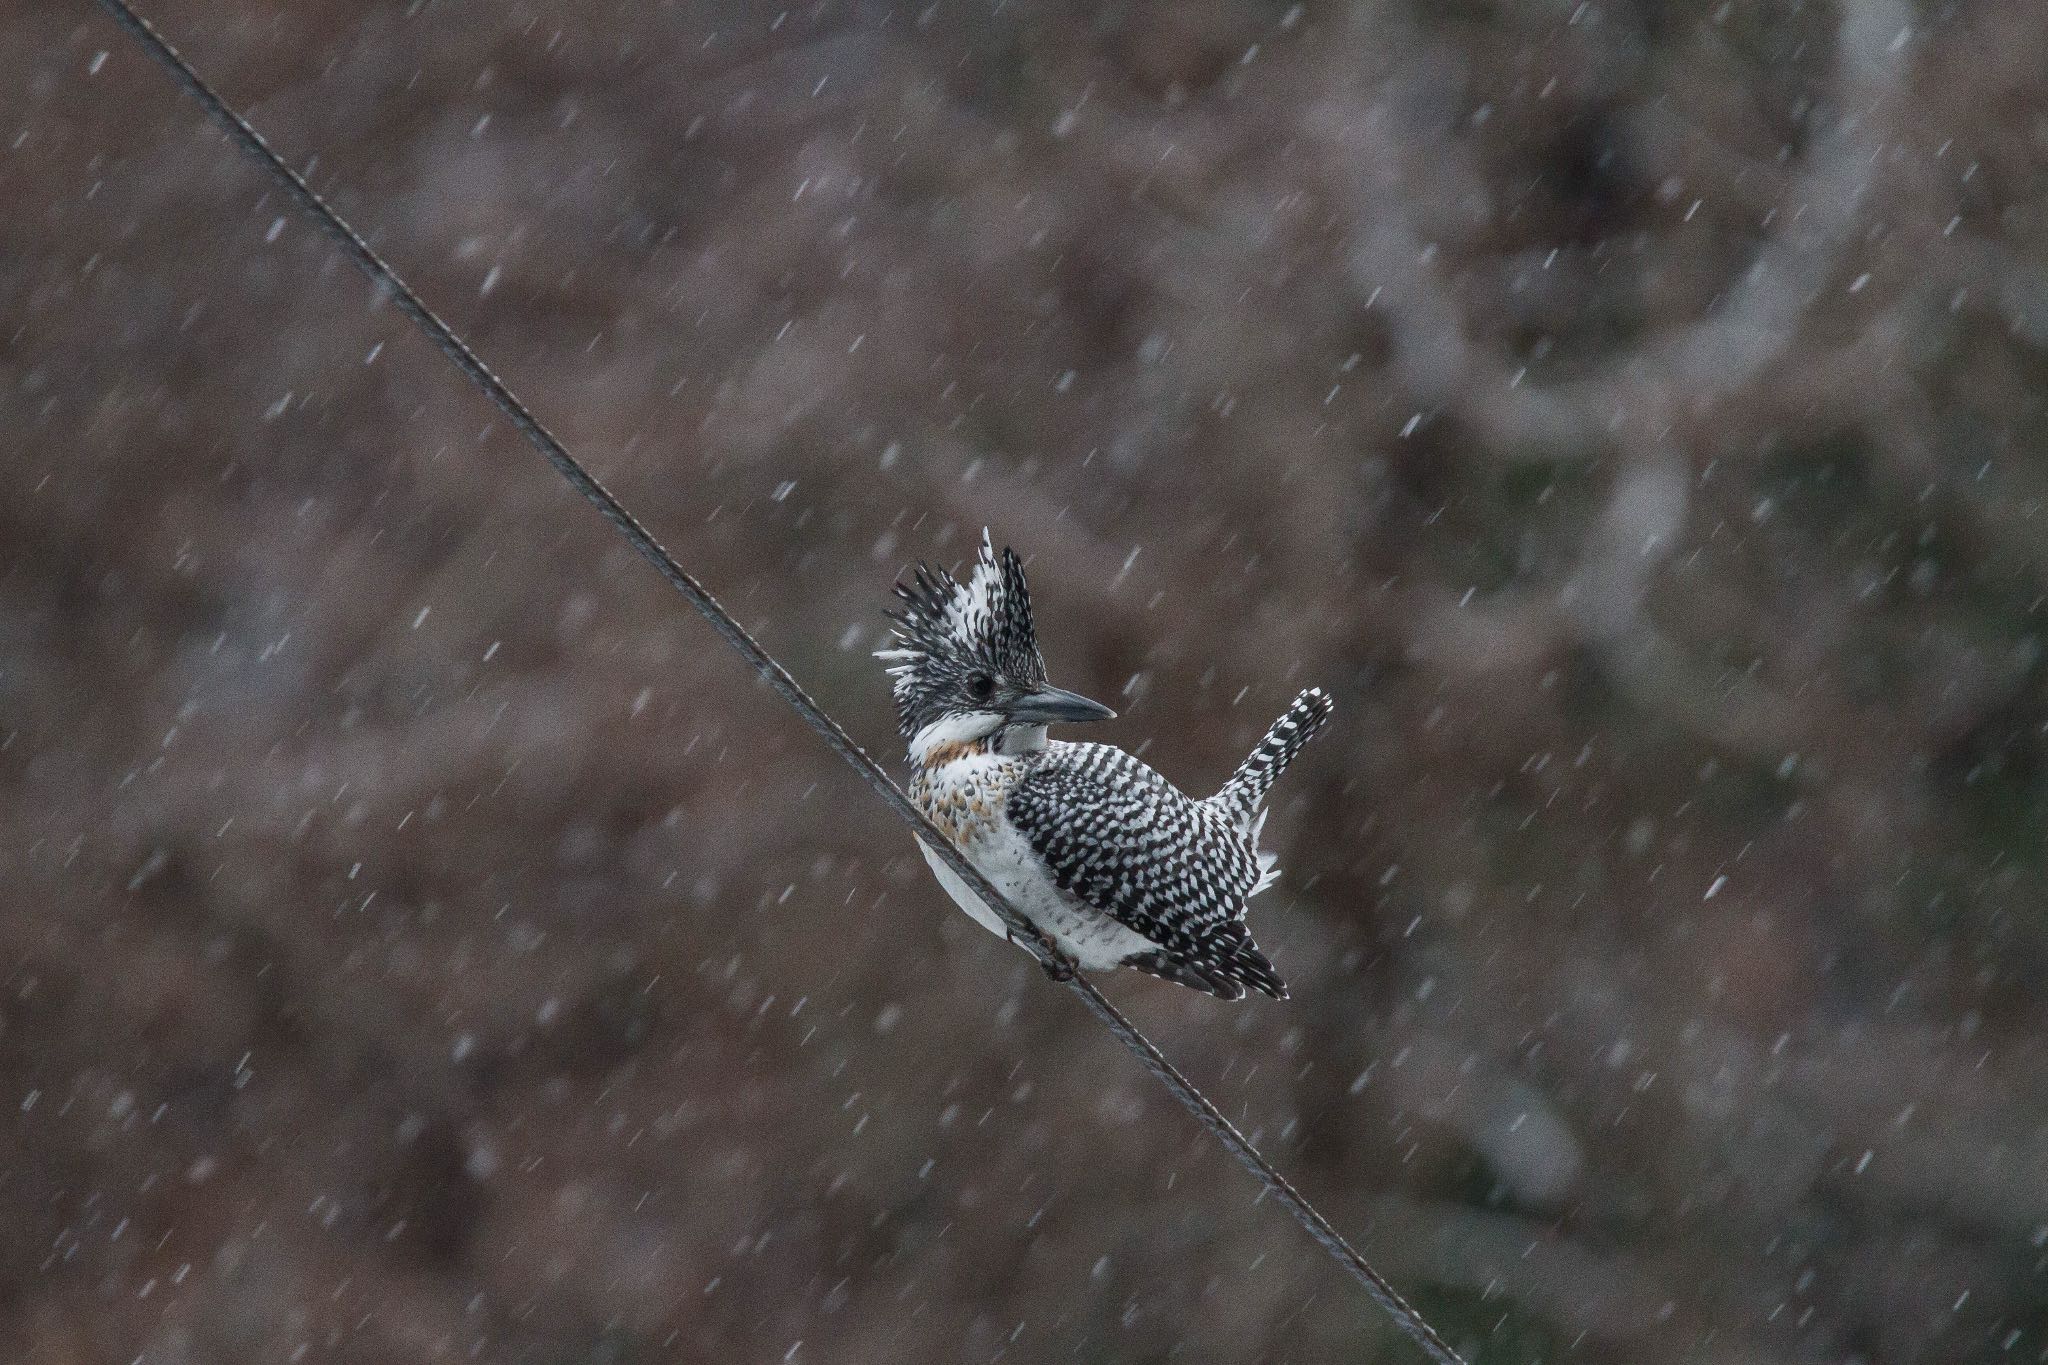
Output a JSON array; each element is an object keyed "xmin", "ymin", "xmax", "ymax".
[{"xmin": 874, "ymin": 530, "xmax": 1333, "ymax": 1001}]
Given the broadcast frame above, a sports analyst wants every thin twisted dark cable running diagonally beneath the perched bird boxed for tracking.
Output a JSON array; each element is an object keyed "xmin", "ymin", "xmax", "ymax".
[{"xmin": 98, "ymin": 0, "xmax": 1462, "ymax": 1365}]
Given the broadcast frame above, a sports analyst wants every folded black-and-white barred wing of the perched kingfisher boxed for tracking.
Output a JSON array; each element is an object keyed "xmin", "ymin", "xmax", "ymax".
[{"xmin": 1004, "ymin": 743, "xmax": 1286, "ymax": 1001}]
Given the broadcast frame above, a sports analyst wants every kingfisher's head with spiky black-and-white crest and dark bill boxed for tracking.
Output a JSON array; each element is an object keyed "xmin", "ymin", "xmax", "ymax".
[{"xmin": 874, "ymin": 532, "xmax": 1116, "ymax": 757}]
